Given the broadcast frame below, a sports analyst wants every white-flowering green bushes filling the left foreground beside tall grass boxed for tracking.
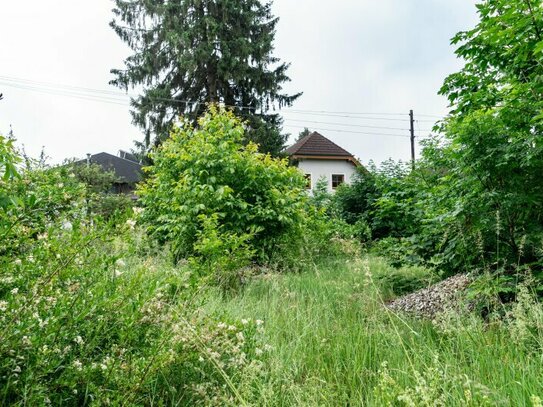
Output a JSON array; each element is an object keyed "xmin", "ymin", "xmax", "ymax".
[{"xmin": 0, "ymin": 141, "xmax": 266, "ymax": 406}]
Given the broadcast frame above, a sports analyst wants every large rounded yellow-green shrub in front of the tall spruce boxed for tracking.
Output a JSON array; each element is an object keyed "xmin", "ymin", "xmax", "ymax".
[{"xmin": 138, "ymin": 108, "xmax": 306, "ymax": 259}]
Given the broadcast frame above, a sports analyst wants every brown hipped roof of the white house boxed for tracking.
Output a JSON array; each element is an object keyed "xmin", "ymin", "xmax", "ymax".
[{"xmin": 286, "ymin": 131, "xmax": 360, "ymax": 165}]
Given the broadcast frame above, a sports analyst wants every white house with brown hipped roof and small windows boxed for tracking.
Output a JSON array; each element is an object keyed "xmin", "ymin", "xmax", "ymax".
[{"xmin": 286, "ymin": 132, "xmax": 361, "ymax": 192}]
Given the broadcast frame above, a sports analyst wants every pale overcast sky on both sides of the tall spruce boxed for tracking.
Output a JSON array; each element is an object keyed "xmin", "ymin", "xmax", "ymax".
[{"xmin": 0, "ymin": 0, "xmax": 477, "ymax": 163}]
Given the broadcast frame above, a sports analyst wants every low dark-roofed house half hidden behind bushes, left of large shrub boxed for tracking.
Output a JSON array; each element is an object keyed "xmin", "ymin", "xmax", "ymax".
[{"xmin": 78, "ymin": 150, "xmax": 143, "ymax": 195}]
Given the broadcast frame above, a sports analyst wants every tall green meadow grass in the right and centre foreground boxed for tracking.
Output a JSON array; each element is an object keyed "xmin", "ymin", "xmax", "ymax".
[{"xmin": 206, "ymin": 258, "xmax": 543, "ymax": 406}]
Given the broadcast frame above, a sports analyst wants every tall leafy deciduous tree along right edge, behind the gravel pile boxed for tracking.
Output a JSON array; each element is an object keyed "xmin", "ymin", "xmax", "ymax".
[{"xmin": 425, "ymin": 0, "xmax": 543, "ymax": 273}]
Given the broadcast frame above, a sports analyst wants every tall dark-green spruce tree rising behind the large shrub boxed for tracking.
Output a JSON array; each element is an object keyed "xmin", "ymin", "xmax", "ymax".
[{"xmin": 111, "ymin": 0, "xmax": 300, "ymax": 154}]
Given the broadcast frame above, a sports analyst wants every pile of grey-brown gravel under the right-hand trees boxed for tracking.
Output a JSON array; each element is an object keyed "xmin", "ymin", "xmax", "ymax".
[{"xmin": 387, "ymin": 274, "xmax": 471, "ymax": 318}]
